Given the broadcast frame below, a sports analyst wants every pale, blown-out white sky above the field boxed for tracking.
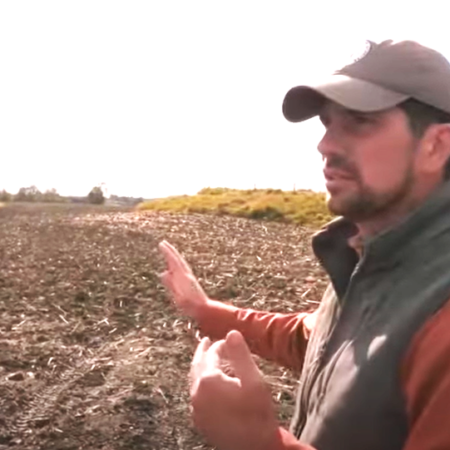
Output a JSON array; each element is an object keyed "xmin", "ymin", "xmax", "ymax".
[{"xmin": 0, "ymin": 0, "xmax": 450, "ymax": 198}]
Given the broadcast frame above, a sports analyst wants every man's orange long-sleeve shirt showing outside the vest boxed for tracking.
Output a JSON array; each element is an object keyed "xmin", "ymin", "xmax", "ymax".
[{"xmin": 199, "ymin": 300, "xmax": 450, "ymax": 450}]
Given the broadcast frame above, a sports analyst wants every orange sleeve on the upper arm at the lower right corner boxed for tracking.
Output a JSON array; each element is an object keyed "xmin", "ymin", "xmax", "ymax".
[{"xmin": 402, "ymin": 301, "xmax": 450, "ymax": 450}]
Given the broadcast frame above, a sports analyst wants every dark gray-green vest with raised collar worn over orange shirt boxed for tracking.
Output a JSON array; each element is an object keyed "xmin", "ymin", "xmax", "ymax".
[{"xmin": 291, "ymin": 182, "xmax": 450, "ymax": 450}]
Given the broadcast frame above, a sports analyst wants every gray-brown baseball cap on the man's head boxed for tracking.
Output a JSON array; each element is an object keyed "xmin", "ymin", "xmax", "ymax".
[{"xmin": 283, "ymin": 40, "xmax": 450, "ymax": 122}]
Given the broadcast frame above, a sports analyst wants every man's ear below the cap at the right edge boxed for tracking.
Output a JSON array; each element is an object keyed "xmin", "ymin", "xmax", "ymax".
[{"xmin": 420, "ymin": 124, "xmax": 450, "ymax": 175}]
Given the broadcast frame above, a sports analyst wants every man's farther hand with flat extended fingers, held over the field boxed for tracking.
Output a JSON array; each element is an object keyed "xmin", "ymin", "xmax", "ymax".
[{"xmin": 159, "ymin": 241, "xmax": 209, "ymax": 319}]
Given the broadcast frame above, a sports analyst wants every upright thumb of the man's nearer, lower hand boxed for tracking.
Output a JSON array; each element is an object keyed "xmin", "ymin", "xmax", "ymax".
[{"xmin": 225, "ymin": 330, "xmax": 262, "ymax": 385}]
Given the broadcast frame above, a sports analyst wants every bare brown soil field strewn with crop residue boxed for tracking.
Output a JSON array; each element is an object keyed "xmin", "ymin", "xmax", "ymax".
[{"xmin": 0, "ymin": 205, "xmax": 326, "ymax": 450}]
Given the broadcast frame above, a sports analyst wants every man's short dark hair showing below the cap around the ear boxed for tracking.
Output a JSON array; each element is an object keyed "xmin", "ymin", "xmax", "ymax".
[{"xmin": 398, "ymin": 99, "xmax": 450, "ymax": 180}]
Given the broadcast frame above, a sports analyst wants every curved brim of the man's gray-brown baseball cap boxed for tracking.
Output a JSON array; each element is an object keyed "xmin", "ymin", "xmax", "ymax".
[{"xmin": 283, "ymin": 74, "xmax": 409, "ymax": 122}]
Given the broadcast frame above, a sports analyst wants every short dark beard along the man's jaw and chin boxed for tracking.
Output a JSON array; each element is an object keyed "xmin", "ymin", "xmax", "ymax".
[{"xmin": 327, "ymin": 156, "xmax": 414, "ymax": 222}]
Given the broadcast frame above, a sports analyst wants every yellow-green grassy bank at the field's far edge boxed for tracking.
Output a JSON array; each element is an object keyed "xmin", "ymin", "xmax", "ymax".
[{"xmin": 137, "ymin": 188, "xmax": 332, "ymax": 227}]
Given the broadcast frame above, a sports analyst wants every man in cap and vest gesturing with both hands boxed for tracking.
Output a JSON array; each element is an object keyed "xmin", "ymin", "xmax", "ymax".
[{"xmin": 160, "ymin": 41, "xmax": 450, "ymax": 450}]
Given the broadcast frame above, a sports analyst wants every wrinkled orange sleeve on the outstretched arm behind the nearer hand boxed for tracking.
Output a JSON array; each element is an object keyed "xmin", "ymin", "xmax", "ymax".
[{"xmin": 198, "ymin": 300, "xmax": 314, "ymax": 371}]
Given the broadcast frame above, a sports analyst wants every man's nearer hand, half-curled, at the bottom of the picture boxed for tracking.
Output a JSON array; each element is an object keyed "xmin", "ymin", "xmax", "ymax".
[{"xmin": 190, "ymin": 331, "xmax": 278, "ymax": 450}]
